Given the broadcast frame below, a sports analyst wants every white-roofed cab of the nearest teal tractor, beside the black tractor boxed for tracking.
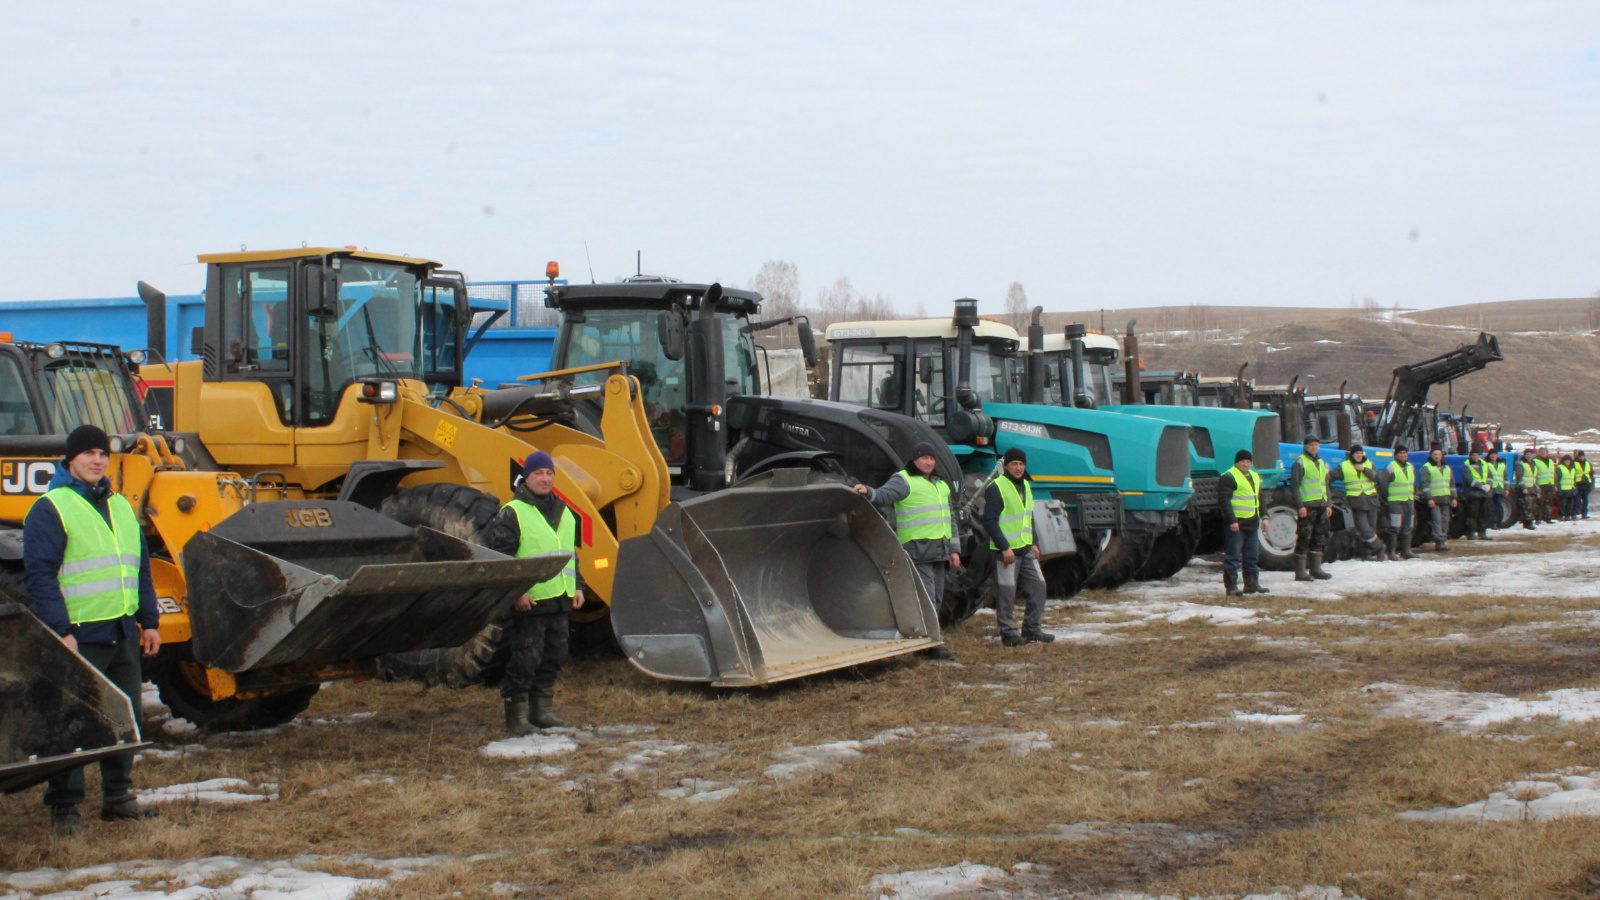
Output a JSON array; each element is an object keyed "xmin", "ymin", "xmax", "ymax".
[{"xmin": 824, "ymin": 317, "xmax": 1018, "ymax": 428}]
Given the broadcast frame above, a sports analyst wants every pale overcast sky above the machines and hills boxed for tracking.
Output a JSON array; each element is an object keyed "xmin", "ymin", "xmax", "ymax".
[{"xmin": 0, "ymin": 0, "xmax": 1600, "ymax": 312}]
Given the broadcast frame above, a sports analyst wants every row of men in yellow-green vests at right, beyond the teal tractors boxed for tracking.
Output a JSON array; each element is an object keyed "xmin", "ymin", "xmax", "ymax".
[{"xmin": 1219, "ymin": 437, "xmax": 1594, "ymax": 596}]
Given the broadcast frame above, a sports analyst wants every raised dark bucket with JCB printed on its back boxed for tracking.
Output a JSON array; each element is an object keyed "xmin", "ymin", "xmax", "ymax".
[{"xmin": 182, "ymin": 500, "xmax": 571, "ymax": 673}]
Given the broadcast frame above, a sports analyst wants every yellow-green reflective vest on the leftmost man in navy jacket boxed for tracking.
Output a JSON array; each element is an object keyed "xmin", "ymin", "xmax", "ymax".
[{"xmin": 45, "ymin": 487, "xmax": 141, "ymax": 625}]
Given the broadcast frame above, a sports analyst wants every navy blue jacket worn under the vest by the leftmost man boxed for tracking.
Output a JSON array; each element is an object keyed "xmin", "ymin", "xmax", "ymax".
[{"xmin": 22, "ymin": 463, "xmax": 162, "ymax": 644}]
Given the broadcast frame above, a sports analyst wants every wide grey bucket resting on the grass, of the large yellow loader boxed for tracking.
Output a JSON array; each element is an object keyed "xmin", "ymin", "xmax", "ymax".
[{"xmin": 611, "ymin": 469, "xmax": 942, "ymax": 687}]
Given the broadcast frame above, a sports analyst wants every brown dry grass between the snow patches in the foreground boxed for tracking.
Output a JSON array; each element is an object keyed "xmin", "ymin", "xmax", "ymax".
[{"xmin": 0, "ymin": 525, "xmax": 1600, "ymax": 898}]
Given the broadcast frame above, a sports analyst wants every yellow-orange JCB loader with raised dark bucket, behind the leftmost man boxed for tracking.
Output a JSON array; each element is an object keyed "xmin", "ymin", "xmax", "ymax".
[{"xmin": 0, "ymin": 341, "xmax": 570, "ymax": 730}]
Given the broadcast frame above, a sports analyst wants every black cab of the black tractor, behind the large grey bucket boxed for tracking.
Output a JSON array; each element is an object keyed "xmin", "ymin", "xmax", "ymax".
[{"xmin": 544, "ymin": 275, "xmax": 762, "ymax": 464}]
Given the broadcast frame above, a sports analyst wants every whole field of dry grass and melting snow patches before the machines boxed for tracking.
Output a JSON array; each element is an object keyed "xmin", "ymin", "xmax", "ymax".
[{"xmin": 0, "ymin": 522, "xmax": 1600, "ymax": 900}]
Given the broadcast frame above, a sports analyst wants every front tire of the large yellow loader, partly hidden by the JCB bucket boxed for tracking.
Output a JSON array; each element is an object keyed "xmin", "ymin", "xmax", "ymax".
[{"xmin": 378, "ymin": 484, "xmax": 515, "ymax": 687}]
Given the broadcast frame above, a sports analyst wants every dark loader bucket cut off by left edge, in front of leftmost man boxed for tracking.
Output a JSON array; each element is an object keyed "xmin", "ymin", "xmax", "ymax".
[{"xmin": 0, "ymin": 604, "xmax": 150, "ymax": 794}]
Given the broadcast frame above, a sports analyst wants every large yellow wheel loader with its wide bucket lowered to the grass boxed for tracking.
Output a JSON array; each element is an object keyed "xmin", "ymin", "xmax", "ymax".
[{"xmin": 139, "ymin": 248, "xmax": 941, "ymax": 685}]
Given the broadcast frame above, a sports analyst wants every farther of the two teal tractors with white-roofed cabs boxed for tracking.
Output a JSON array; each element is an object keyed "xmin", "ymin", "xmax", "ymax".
[{"xmin": 1035, "ymin": 318, "xmax": 1283, "ymax": 560}]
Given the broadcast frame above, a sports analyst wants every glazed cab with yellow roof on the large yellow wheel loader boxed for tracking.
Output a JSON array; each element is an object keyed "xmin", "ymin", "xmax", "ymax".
[{"xmin": 194, "ymin": 248, "xmax": 470, "ymax": 428}]
